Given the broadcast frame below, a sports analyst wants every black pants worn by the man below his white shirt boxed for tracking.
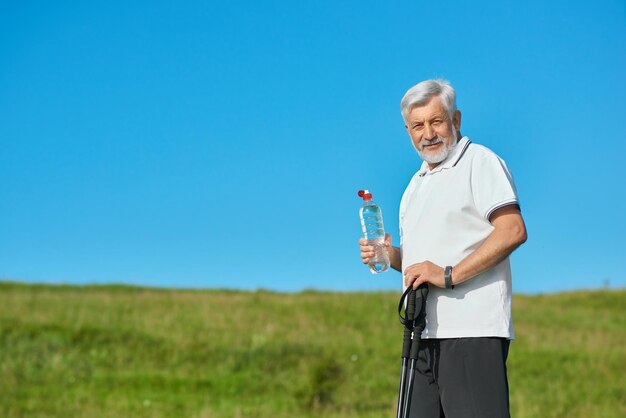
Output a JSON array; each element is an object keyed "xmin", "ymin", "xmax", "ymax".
[{"xmin": 410, "ymin": 338, "xmax": 510, "ymax": 418}]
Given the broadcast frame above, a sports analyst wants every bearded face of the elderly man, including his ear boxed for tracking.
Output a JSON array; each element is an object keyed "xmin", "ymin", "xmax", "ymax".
[{"xmin": 406, "ymin": 97, "xmax": 461, "ymax": 169}]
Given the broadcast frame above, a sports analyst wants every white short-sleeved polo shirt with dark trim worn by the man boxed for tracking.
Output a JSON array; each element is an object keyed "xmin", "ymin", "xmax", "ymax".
[{"xmin": 400, "ymin": 137, "xmax": 518, "ymax": 339}]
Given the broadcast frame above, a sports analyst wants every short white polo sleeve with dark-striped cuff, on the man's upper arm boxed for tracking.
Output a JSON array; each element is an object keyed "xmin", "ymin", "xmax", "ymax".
[{"xmin": 471, "ymin": 152, "xmax": 519, "ymax": 220}]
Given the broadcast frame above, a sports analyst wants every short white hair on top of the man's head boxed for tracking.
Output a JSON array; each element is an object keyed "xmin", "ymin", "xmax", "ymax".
[{"xmin": 400, "ymin": 78, "xmax": 456, "ymax": 124}]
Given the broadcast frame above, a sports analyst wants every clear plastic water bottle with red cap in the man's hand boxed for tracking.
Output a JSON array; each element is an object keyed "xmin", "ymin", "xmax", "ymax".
[{"xmin": 359, "ymin": 190, "xmax": 389, "ymax": 274}]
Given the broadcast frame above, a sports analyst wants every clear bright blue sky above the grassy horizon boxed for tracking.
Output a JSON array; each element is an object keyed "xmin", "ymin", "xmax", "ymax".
[{"xmin": 0, "ymin": 0, "xmax": 626, "ymax": 293}]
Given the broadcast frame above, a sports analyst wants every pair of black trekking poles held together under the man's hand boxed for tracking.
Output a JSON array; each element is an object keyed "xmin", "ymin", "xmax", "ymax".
[{"xmin": 396, "ymin": 283, "xmax": 428, "ymax": 418}]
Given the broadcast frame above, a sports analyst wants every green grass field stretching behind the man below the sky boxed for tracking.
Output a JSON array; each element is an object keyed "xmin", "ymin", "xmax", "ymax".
[{"xmin": 0, "ymin": 282, "xmax": 626, "ymax": 418}]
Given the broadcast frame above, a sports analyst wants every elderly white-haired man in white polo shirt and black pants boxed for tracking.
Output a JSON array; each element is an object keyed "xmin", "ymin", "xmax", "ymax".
[{"xmin": 359, "ymin": 80, "xmax": 526, "ymax": 418}]
